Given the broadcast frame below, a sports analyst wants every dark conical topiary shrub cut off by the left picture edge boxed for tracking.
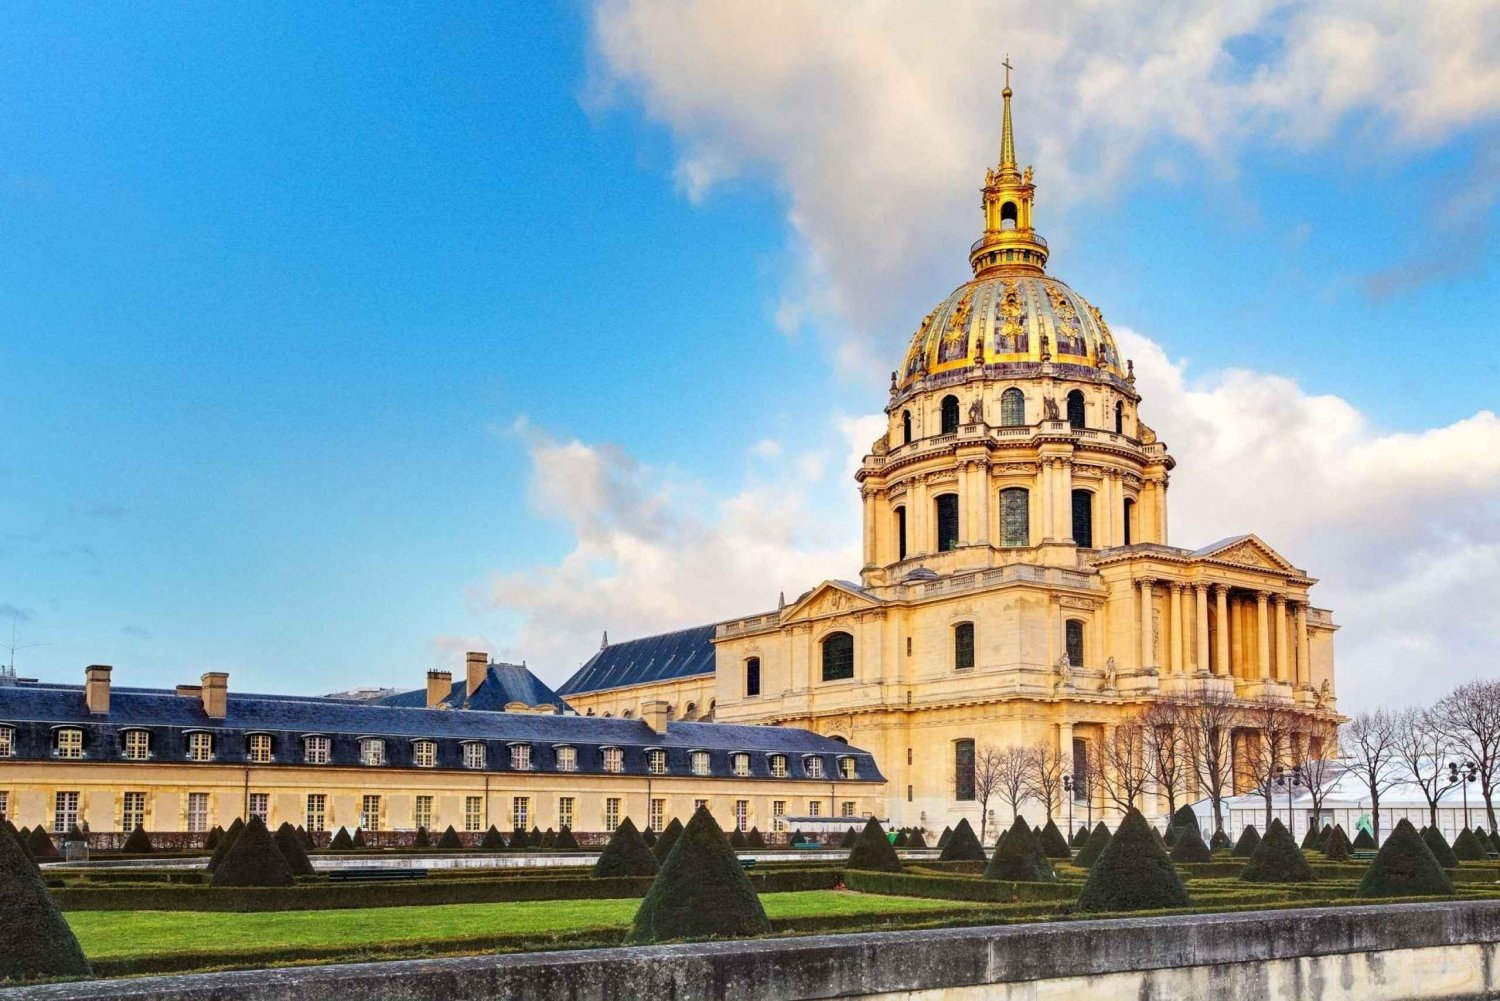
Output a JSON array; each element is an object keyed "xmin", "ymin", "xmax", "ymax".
[{"xmin": 0, "ymin": 825, "xmax": 93, "ymax": 980}]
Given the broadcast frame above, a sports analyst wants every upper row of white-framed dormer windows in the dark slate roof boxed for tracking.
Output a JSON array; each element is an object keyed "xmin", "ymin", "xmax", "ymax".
[{"xmin": 0, "ymin": 729, "xmax": 860, "ymax": 779}]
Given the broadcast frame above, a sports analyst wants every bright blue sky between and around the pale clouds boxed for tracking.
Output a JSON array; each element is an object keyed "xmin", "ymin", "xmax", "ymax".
[{"xmin": 0, "ymin": 3, "xmax": 1500, "ymax": 705}]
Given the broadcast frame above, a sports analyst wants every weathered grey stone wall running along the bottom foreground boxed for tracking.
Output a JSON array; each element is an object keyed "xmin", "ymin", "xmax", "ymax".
[{"xmin": 0, "ymin": 900, "xmax": 1500, "ymax": 1001}]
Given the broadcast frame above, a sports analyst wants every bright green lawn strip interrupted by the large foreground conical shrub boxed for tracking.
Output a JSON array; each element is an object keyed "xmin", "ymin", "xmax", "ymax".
[{"xmin": 66, "ymin": 890, "xmax": 975, "ymax": 959}]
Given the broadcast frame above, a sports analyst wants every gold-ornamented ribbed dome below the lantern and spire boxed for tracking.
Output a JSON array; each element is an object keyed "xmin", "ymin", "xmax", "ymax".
[{"xmin": 897, "ymin": 273, "xmax": 1125, "ymax": 389}]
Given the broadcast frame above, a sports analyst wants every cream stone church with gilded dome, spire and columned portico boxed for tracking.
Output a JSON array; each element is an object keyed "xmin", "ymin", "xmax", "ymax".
[{"xmin": 560, "ymin": 81, "xmax": 1338, "ymax": 830}]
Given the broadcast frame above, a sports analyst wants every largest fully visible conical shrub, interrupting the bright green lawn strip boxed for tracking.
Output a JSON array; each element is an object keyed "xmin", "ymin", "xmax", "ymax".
[{"xmin": 626, "ymin": 807, "xmax": 771, "ymax": 944}]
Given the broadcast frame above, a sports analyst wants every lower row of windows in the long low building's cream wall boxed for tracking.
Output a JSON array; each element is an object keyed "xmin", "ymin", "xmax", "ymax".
[{"xmin": 20, "ymin": 792, "xmax": 870, "ymax": 834}]
